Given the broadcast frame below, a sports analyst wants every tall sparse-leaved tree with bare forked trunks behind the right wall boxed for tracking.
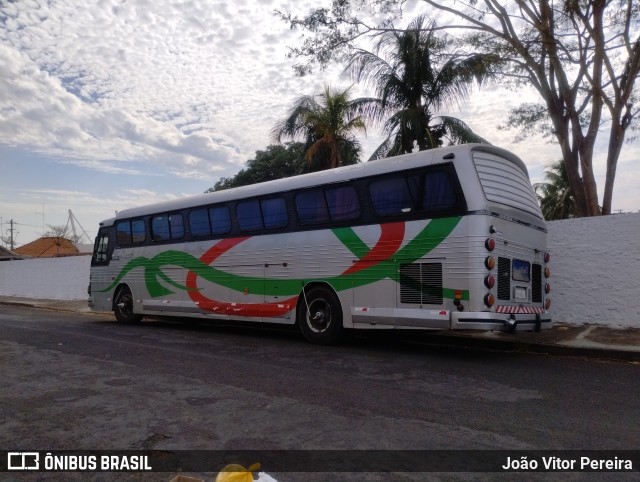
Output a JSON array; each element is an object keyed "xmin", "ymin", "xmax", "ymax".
[{"xmin": 281, "ymin": 0, "xmax": 640, "ymax": 216}]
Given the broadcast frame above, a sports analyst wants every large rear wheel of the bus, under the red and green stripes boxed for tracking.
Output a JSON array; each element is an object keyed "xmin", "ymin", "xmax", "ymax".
[{"xmin": 298, "ymin": 286, "xmax": 344, "ymax": 345}]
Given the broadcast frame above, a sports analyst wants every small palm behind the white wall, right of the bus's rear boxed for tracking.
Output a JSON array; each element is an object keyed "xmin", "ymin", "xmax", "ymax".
[{"xmin": 533, "ymin": 160, "xmax": 580, "ymax": 221}]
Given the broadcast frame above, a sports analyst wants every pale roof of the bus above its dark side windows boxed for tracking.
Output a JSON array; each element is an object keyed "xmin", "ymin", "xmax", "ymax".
[{"xmin": 100, "ymin": 144, "xmax": 528, "ymax": 226}]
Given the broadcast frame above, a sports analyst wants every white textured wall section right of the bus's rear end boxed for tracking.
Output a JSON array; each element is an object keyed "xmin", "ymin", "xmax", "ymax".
[{"xmin": 547, "ymin": 213, "xmax": 640, "ymax": 327}]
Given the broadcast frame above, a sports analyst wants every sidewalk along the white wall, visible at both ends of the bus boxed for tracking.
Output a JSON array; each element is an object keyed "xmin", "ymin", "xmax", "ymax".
[{"xmin": 0, "ymin": 296, "xmax": 640, "ymax": 362}]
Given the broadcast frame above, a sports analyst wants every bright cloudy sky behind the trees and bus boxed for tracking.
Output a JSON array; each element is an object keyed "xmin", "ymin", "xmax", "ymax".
[{"xmin": 0, "ymin": 0, "xmax": 640, "ymax": 245}]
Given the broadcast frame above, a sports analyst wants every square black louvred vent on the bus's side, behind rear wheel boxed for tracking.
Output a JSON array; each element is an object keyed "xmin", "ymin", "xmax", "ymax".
[{"xmin": 400, "ymin": 263, "xmax": 442, "ymax": 305}]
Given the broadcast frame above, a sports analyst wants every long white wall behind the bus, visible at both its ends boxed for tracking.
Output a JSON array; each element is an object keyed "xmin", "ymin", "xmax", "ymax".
[{"xmin": 0, "ymin": 214, "xmax": 640, "ymax": 328}]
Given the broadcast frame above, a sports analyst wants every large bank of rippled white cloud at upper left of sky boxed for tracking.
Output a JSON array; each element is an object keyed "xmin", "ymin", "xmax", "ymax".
[{"xmin": 0, "ymin": 0, "xmax": 332, "ymax": 178}]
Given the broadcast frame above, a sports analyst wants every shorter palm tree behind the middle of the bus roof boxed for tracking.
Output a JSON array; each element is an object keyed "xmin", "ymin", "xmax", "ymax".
[{"xmin": 271, "ymin": 86, "xmax": 372, "ymax": 170}]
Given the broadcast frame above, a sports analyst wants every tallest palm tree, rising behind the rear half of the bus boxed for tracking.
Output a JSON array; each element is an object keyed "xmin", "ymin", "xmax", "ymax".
[{"xmin": 345, "ymin": 17, "xmax": 498, "ymax": 159}]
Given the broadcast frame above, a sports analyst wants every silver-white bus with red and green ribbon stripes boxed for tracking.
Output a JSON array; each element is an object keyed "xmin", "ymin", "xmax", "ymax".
[{"xmin": 89, "ymin": 144, "xmax": 551, "ymax": 344}]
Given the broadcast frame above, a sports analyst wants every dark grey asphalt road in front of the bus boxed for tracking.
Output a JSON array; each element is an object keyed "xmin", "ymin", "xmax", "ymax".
[{"xmin": 0, "ymin": 305, "xmax": 640, "ymax": 482}]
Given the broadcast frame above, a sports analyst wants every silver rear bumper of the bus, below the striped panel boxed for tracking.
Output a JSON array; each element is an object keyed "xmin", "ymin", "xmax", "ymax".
[{"xmin": 451, "ymin": 311, "xmax": 551, "ymax": 332}]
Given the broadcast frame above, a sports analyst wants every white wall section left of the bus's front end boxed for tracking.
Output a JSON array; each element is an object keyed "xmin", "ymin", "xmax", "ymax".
[{"xmin": 0, "ymin": 256, "xmax": 91, "ymax": 300}]
